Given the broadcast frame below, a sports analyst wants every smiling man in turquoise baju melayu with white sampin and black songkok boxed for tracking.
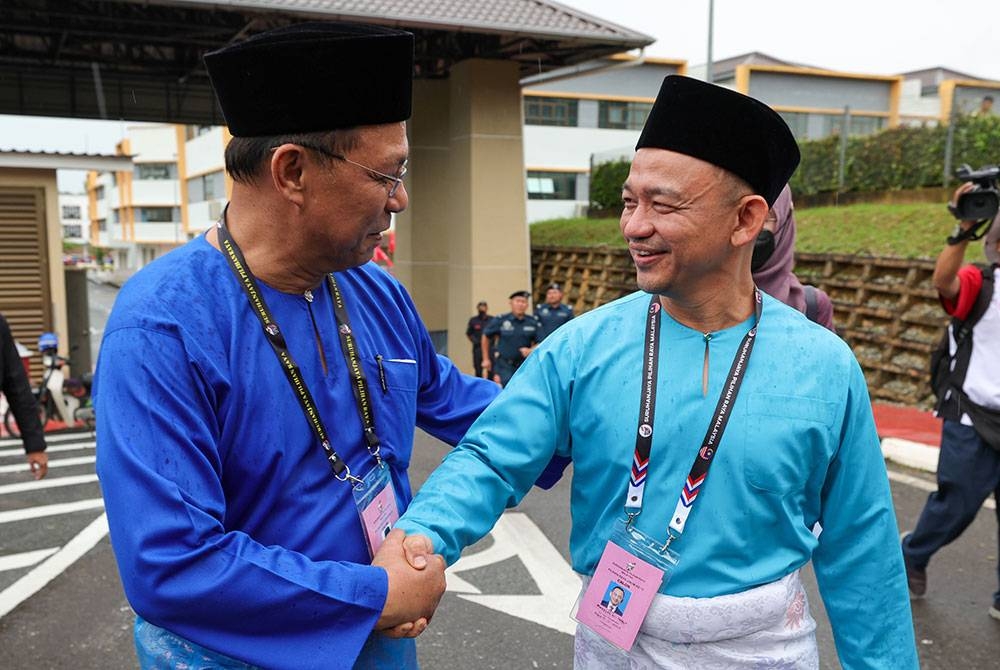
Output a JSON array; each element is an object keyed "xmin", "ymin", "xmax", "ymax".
[{"xmin": 397, "ymin": 76, "xmax": 917, "ymax": 670}]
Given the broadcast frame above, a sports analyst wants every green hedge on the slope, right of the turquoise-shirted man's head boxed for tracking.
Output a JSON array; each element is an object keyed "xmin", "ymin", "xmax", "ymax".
[{"xmin": 790, "ymin": 115, "xmax": 1000, "ymax": 195}]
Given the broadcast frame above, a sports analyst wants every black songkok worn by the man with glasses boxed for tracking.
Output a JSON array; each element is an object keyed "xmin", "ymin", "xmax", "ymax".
[{"xmin": 205, "ymin": 23, "xmax": 413, "ymax": 137}]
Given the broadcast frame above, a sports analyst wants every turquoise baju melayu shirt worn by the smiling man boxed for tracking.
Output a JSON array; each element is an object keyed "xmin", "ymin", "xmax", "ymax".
[{"xmin": 397, "ymin": 293, "xmax": 916, "ymax": 670}]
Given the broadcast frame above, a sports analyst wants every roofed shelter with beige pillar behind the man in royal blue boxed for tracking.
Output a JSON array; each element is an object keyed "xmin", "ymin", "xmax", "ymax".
[{"xmin": 0, "ymin": 0, "xmax": 653, "ymax": 370}]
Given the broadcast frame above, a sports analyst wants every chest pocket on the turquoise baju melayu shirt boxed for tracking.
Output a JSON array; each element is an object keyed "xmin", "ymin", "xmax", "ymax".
[{"xmin": 743, "ymin": 393, "xmax": 837, "ymax": 495}]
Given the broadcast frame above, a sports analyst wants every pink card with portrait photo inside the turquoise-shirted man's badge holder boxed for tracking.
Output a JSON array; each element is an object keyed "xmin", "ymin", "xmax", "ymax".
[{"xmin": 575, "ymin": 540, "xmax": 664, "ymax": 651}]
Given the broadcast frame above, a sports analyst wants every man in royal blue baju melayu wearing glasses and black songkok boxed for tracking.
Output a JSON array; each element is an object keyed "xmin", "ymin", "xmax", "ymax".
[{"xmin": 95, "ymin": 24, "xmax": 499, "ymax": 670}]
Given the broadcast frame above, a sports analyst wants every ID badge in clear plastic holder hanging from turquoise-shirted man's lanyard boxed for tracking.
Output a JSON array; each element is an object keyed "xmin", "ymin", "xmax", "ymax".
[{"xmin": 573, "ymin": 520, "xmax": 679, "ymax": 651}]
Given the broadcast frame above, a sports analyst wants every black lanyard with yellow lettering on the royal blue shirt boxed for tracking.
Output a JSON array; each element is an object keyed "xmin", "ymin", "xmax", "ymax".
[{"xmin": 218, "ymin": 220, "xmax": 382, "ymax": 485}]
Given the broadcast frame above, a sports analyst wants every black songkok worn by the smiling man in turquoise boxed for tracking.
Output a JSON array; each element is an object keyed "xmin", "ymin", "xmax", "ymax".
[{"xmin": 635, "ymin": 75, "xmax": 799, "ymax": 206}]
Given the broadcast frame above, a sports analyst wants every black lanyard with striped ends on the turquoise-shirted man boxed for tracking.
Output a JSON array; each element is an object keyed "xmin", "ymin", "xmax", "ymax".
[{"xmin": 625, "ymin": 287, "xmax": 762, "ymax": 549}]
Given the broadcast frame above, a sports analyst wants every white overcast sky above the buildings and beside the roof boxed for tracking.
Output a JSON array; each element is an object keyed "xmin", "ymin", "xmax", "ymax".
[{"xmin": 0, "ymin": 0, "xmax": 1000, "ymax": 191}]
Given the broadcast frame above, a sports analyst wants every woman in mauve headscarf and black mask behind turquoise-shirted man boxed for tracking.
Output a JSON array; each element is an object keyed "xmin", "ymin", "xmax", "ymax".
[{"xmin": 751, "ymin": 184, "xmax": 836, "ymax": 332}]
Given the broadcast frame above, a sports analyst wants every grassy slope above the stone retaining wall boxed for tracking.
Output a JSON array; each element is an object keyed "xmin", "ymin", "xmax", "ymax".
[{"xmin": 531, "ymin": 204, "xmax": 985, "ymax": 262}]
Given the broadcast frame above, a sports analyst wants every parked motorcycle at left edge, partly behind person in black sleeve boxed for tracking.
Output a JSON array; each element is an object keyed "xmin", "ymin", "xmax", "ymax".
[{"xmin": 3, "ymin": 333, "xmax": 96, "ymax": 437}]
